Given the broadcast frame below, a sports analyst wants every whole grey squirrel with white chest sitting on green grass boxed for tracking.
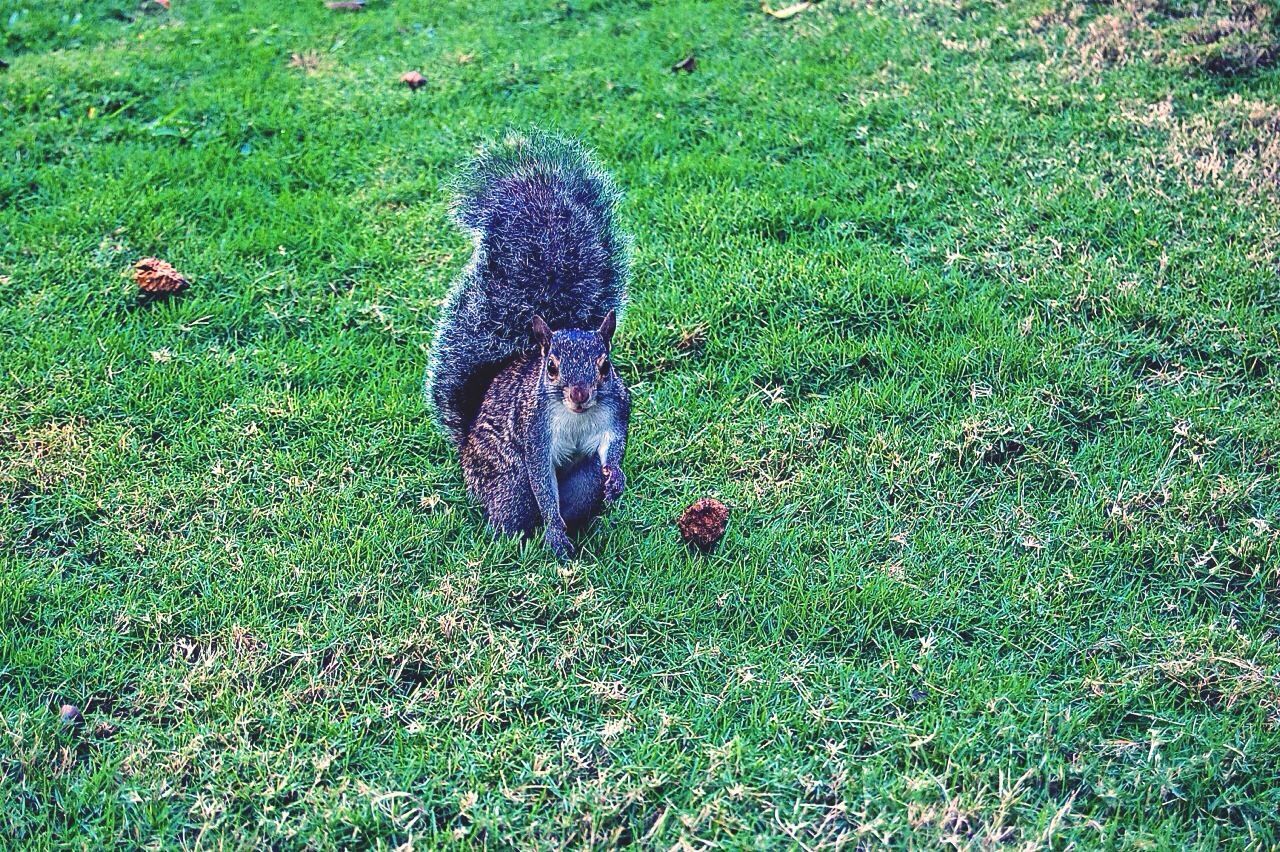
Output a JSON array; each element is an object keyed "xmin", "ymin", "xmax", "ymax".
[{"xmin": 426, "ymin": 132, "xmax": 631, "ymax": 559}]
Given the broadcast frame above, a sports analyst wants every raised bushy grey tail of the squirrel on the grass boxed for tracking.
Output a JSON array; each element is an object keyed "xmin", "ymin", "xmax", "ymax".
[{"xmin": 428, "ymin": 130, "xmax": 628, "ymax": 445}]
